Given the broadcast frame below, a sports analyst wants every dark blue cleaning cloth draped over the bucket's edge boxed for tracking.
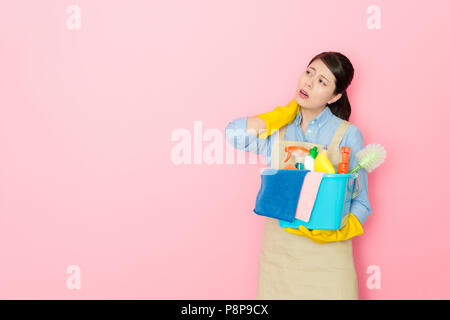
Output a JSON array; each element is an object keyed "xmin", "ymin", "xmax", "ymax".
[{"xmin": 253, "ymin": 169, "xmax": 310, "ymax": 222}]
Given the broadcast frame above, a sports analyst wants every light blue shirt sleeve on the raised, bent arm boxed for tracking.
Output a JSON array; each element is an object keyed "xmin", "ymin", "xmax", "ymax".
[{"xmin": 225, "ymin": 117, "xmax": 270, "ymax": 158}]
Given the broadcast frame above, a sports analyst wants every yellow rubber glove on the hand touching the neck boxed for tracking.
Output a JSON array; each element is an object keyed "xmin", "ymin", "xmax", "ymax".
[{"xmin": 255, "ymin": 99, "xmax": 300, "ymax": 139}]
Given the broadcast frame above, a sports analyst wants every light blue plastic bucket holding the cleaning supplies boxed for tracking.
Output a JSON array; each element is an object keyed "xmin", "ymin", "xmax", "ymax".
[{"xmin": 279, "ymin": 173, "xmax": 361, "ymax": 230}]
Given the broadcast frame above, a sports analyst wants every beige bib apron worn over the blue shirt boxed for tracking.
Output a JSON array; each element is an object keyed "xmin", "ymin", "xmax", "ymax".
[{"xmin": 257, "ymin": 120, "xmax": 358, "ymax": 300}]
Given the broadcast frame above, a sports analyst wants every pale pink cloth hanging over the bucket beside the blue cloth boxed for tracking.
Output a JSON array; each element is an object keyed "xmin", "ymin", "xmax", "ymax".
[{"xmin": 295, "ymin": 172, "xmax": 324, "ymax": 222}]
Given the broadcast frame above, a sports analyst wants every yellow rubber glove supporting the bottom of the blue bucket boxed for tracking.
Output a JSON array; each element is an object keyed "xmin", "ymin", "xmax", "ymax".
[{"xmin": 284, "ymin": 213, "xmax": 364, "ymax": 243}]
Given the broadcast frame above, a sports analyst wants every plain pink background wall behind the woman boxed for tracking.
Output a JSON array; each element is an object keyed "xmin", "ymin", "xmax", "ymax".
[{"xmin": 0, "ymin": 0, "xmax": 450, "ymax": 299}]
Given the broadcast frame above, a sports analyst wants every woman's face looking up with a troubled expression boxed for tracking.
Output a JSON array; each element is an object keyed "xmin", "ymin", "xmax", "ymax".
[{"xmin": 295, "ymin": 59, "xmax": 342, "ymax": 111}]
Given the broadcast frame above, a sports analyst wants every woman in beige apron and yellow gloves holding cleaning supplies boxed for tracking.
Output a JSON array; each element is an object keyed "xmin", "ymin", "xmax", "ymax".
[{"xmin": 226, "ymin": 52, "xmax": 371, "ymax": 299}]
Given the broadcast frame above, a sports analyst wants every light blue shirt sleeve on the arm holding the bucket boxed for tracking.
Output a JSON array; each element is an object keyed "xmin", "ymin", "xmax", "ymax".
[{"xmin": 341, "ymin": 124, "xmax": 372, "ymax": 224}]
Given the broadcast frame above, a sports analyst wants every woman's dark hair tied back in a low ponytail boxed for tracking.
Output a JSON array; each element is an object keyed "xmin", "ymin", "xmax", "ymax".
[{"xmin": 308, "ymin": 51, "xmax": 354, "ymax": 121}]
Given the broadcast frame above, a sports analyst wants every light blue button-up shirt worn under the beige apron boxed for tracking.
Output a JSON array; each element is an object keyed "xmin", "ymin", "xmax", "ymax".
[{"xmin": 225, "ymin": 107, "xmax": 372, "ymax": 224}]
